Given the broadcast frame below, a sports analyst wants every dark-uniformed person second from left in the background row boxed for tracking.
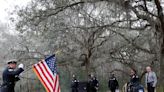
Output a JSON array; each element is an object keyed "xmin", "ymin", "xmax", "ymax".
[{"xmin": 87, "ymin": 75, "xmax": 99, "ymax": 92}]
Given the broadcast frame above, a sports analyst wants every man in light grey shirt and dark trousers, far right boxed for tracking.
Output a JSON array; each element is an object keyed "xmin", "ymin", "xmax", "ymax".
[{"xmin": 145, "ymin": 66, "xmax": 157, "ymax": 92}]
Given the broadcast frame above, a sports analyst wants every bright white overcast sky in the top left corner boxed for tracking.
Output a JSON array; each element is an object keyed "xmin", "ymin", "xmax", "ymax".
[{"xmin": 0, "ymin": 0, "xmax": 31, "ymax": 35}]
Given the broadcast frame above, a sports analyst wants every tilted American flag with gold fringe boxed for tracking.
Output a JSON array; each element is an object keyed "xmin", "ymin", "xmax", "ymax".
[{"xmin": 33, "ymin": 55, "xmax": 60, "ymax": 92}]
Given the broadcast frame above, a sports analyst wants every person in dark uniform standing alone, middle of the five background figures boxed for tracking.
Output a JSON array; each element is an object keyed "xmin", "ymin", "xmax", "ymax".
[{"xmin": 108, "ymin": 74, "xmax": 119, "ymax": 92}]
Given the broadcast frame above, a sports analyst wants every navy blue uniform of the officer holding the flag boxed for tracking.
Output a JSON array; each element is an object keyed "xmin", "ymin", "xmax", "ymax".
[{"xmin": 0, "ymin": 67, "xmax": 24, "ymax": 92}]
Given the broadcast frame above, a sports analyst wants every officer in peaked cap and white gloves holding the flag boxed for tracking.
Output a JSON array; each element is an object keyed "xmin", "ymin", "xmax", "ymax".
[{"xmin": 1, "ymin": 60, "xmax": 24, "ymax": 92}]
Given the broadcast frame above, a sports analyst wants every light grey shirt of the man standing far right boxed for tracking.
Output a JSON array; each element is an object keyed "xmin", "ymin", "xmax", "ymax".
[{"xmin": 145, "ymin": 72, "xmax": 157, "ymax": 87}]
